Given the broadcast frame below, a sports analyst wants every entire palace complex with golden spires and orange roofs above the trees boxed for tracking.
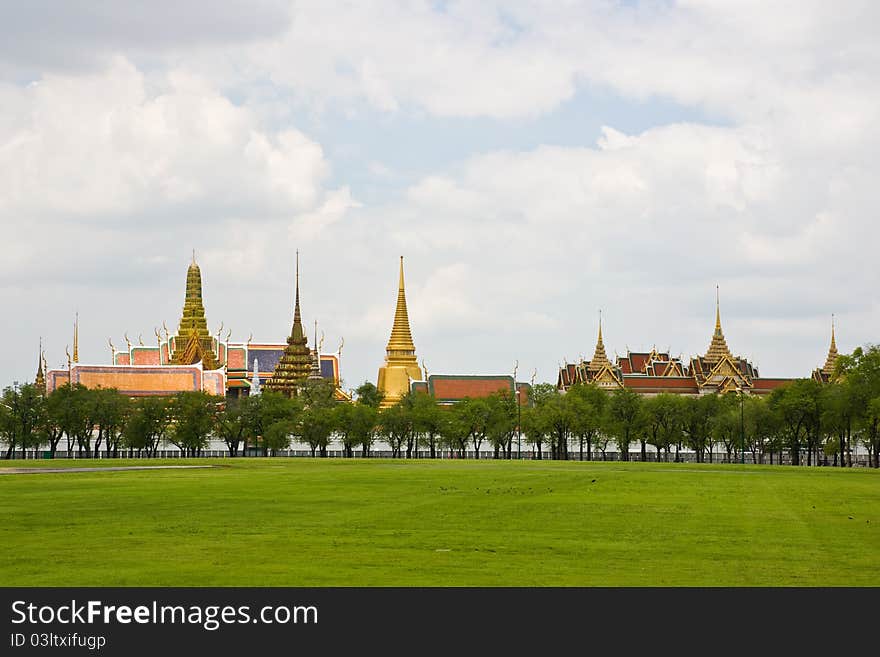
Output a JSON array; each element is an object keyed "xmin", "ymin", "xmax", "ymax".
[{"xmin": 36, "ymin": 254, "xmax": 837, "ymax": 407}]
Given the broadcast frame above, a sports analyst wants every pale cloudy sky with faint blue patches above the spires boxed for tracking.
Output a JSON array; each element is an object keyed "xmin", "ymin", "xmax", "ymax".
[{"xmin": 0, "ymin": 0, "xmax": 880, "ymax": 387}]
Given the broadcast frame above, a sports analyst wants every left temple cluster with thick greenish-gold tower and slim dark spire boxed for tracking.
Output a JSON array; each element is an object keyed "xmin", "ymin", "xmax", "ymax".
[{"xmin": 43, "ymin": 254, "xmax": 349, "ymax": 399}]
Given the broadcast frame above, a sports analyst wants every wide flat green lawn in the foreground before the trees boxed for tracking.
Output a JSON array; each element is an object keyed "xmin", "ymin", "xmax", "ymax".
[{"xmin": 0, "ymin": 459, "xmax": 880, "ymax": 586}]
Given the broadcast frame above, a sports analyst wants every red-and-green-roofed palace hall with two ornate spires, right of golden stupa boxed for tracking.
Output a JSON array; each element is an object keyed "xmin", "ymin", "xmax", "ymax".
[{"xmin": 556, "ymin": 290, "xmax": 793, "ymax": 395}]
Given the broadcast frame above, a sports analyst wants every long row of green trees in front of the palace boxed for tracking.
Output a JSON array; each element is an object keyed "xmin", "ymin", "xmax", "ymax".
[{"xmin": 0, "ymin": 346, "xmax": 880, "ymax": 467}]
